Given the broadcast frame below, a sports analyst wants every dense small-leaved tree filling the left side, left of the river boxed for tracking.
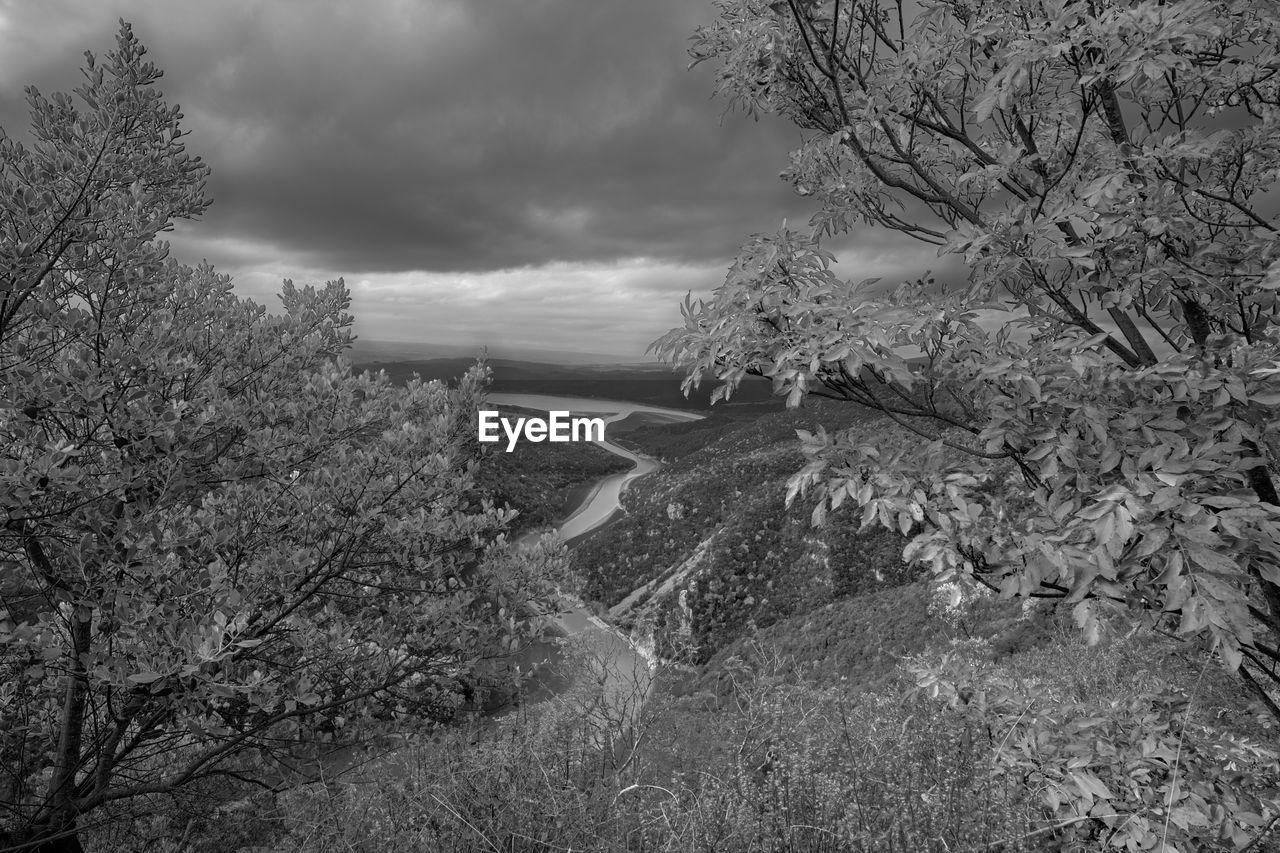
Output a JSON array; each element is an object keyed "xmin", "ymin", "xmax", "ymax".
[{"xmin": 0, "ymin": 22, "xmax": 552, "ymax": 850}]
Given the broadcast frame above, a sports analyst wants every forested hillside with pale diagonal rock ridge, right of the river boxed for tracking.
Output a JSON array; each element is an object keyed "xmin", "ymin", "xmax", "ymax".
[{"xmin": 573, "ymin": 402, "xmax": 914, "ymax": 662}]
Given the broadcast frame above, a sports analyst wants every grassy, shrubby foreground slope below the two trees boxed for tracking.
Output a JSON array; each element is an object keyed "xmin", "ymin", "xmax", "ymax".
[{"xmin": 87, "ymin": 596, "xmax": 1276, "ymax": 853}]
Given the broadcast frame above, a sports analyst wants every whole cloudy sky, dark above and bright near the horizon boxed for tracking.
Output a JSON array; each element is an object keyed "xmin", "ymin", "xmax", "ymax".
[{"xmin": 0, "ymin": 0, "xmax": 941, "ymax": 360}]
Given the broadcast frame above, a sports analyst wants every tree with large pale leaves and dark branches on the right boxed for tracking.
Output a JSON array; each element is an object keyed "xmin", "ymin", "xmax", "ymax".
[{"xmin": 654, "ymin": 0, "xmax": 1280, "ymax": 716}]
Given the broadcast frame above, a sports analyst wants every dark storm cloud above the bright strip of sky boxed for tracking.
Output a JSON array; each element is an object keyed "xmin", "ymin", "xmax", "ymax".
[{"xmin": 4, "ymin": 0, "xmax": 804, "ymax": 272}]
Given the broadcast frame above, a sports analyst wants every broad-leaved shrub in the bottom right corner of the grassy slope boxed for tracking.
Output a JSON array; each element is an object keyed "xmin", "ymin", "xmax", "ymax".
[{"xmin": 908, "ymin": 622, "xmax": 1280, "ymax": 850}]
